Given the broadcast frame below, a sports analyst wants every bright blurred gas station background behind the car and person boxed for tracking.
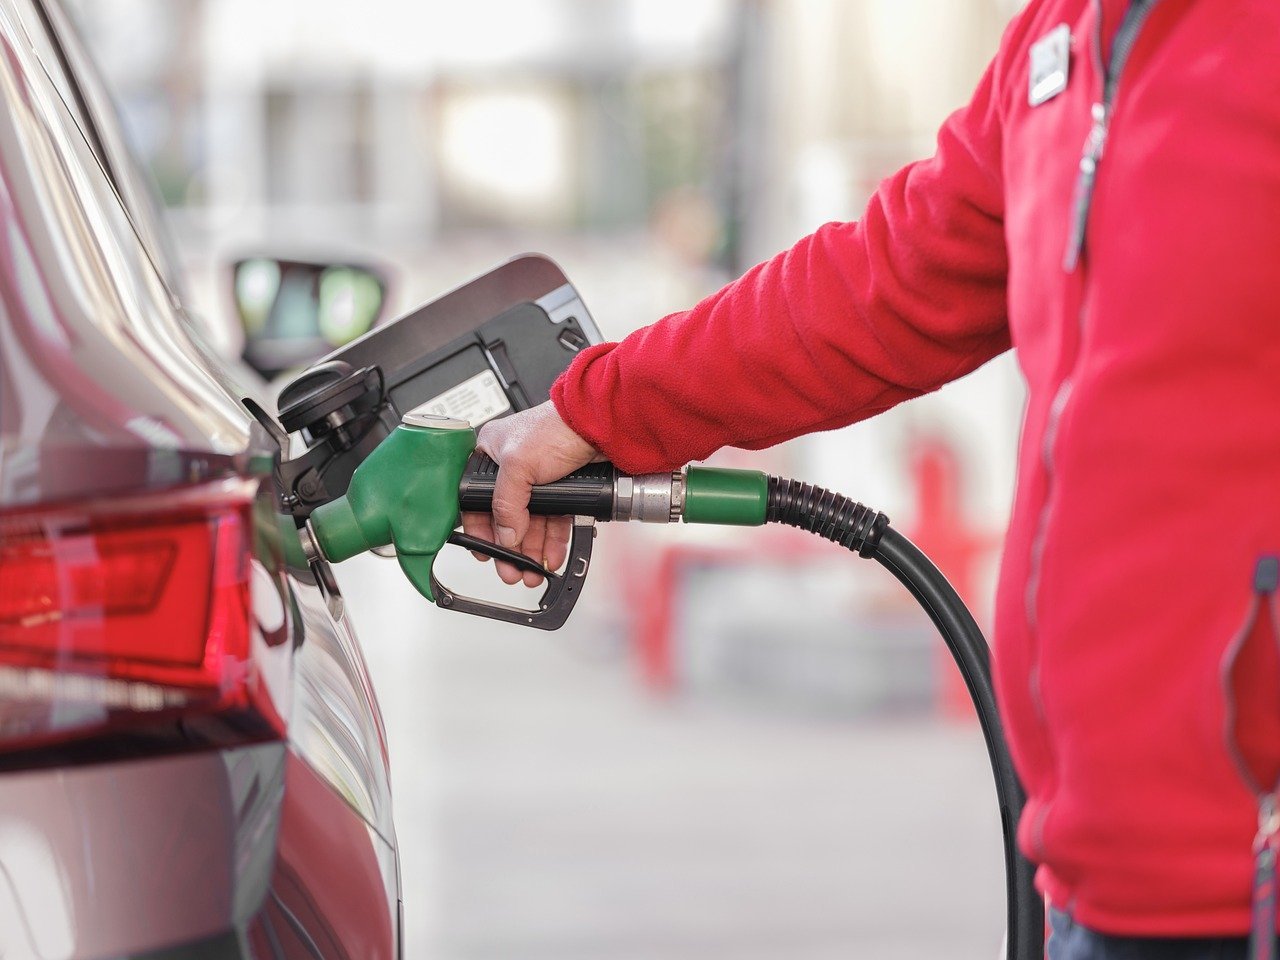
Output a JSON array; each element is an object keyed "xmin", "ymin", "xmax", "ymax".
[{"xmin": 73, "ymin": 0, "xmax": 1023, "ymax": 960}]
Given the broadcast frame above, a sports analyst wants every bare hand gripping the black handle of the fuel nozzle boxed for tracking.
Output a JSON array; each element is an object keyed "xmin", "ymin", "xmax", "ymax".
[{"xmin": 462, "ymin": 401, "xmax": 603, "ymax": 586}]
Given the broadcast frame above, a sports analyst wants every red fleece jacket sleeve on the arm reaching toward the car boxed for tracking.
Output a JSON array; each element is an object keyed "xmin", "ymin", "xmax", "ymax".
[{"xmin": 552, "ymin": 35, "xmax": 1010, "ymax": 472}]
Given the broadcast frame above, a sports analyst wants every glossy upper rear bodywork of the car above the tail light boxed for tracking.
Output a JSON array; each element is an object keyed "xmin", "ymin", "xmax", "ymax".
[{"xmin": 0, "ymin": 0, "xmax": 252, "ymax": 507}]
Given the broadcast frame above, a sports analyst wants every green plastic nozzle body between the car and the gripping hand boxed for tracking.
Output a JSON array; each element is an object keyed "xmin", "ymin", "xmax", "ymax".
[{"xmin": 310, "ymin": 413, "xmax": 476, "ymax": 602}]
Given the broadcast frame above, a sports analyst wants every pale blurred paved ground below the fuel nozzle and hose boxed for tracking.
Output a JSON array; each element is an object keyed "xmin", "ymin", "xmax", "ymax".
[{"xmin": 343, "ymin": 558, "xmax": 1004, "ymax": 960}]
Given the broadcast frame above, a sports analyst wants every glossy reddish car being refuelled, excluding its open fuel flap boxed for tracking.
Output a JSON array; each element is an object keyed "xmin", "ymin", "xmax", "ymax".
[{"xmin": 0, "ymin": 0, "xmax": 401, "ymax": 960}]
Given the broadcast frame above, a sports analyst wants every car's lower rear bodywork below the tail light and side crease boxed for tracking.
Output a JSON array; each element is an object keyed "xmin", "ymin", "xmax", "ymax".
[{"xmin": 0, "ymin": 744, "xmax": 398, "ymax": 960}]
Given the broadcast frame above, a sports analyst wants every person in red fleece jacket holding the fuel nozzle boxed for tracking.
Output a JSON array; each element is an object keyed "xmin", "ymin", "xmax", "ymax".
[{"xmin": 465, "ymin": 0, "xmax": 1280, "ymax": 960}]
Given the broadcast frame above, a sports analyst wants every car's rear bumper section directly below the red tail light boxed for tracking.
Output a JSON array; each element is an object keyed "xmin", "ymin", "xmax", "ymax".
[{"xmin": 0, "ymin": 744, "xmax": 285, "ymax": 960}]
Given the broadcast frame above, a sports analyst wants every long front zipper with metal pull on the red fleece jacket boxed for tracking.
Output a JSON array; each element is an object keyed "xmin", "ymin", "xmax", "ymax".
[{"xmin": 1025, "ymin": 0, "xmax": 1160, "ymax": 859}]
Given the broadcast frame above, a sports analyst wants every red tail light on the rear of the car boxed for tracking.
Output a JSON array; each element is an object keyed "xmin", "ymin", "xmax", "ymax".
[{"xmin": 0, "ymin": 486, "xmax": 280, "ymax": 749}]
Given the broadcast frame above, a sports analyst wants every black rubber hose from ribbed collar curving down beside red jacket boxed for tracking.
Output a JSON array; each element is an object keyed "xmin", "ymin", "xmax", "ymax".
[{"xmin": 767, "ymin": 476, "xmax": 1044, "ymax": 960}]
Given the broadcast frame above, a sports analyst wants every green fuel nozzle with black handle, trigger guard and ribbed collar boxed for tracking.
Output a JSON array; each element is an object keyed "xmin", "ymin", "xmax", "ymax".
[{"xmin": 303, "ymin": 412, "xmax": 888, "ymax": 630}]
